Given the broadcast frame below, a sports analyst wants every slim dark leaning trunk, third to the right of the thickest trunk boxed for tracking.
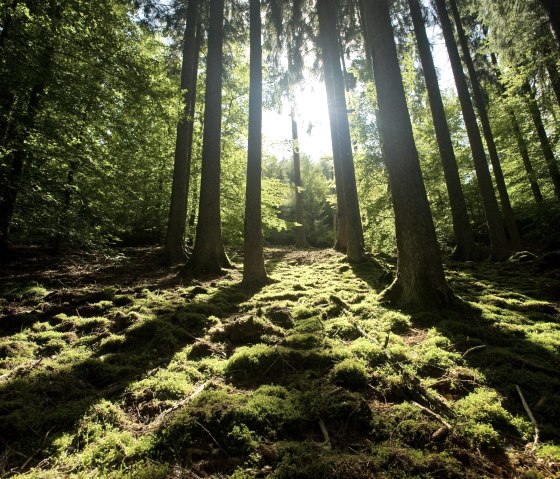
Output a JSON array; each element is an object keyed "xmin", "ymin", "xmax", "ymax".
[{"xmin": 449, "ymin": 0, "xmax": 521, "ymax": 250}]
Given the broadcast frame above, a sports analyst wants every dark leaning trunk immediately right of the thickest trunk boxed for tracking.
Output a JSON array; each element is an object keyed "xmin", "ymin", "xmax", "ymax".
[{"xmin": 408, "ymin": 0, "xmax": 479, "ymax": 260}]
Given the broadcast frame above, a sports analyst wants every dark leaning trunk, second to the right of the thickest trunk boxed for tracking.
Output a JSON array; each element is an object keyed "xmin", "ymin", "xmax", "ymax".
[{"xmin": 434, "ymin": 0, "xmax": 510, "ymax": 260}]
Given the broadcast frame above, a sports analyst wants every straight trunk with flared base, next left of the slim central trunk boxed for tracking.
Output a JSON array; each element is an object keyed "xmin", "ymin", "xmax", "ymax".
[{"xmin": 186, "ymin": 0, "xmax": 230, "ymax": 273}]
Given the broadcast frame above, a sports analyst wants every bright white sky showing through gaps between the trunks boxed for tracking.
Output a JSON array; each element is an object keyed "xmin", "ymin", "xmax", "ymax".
[{"xmin": 263, "ymin": 21, "xmax": 454, "ymax": 161}]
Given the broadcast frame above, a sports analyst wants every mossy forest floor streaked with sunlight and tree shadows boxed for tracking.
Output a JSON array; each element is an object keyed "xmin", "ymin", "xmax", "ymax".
[{"xmin": 0, "ymin": 248, "xmax": 560, "ymax": 479}]
